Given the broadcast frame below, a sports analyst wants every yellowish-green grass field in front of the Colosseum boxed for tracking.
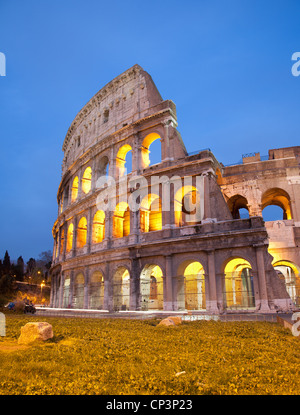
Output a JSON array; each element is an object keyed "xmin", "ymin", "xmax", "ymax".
[{"xmin": 0, "ymin": 315, "xmax": 300, "ymax": 395}]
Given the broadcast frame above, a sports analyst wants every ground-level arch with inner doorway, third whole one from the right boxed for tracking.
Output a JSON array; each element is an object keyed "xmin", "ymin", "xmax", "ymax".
[{"xmin": 140, "ymin": 264, "xmax": 164, "ymax": 311}]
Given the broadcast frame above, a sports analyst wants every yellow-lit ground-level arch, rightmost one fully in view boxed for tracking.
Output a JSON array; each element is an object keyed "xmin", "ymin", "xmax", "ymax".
[{"xmin": 223, "ymin": 258, "xmax": 255, "ymax": 309}]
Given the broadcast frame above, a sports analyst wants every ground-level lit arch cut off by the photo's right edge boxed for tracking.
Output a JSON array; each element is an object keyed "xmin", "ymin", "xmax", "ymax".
[{"xmin": 273, "ymin": 260, "xmax": 300, "ymax": 307}]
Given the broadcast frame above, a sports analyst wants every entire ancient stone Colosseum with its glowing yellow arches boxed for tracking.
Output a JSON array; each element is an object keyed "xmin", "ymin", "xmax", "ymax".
[{"xmin": 50, "ymin": 65, "xmax": 300, "ymax": 314}]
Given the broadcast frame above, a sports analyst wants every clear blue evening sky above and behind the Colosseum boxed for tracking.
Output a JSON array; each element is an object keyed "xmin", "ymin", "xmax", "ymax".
[{"xmin": 0, "ymin": 0, "xmax": 300, "ymax": 260}]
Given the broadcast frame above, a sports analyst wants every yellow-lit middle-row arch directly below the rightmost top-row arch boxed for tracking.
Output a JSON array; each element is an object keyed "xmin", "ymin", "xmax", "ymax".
[{"xmin": 140, "ymin": 193, "xmax": 162, "ymax": 232}]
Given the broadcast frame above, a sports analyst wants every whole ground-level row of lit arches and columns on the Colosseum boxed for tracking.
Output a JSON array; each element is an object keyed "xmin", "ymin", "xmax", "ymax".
[{"xmin": 50, "ymin": 252, "xmax": 300, "ymax": 313}]
